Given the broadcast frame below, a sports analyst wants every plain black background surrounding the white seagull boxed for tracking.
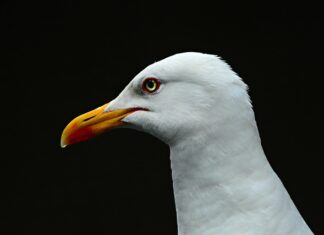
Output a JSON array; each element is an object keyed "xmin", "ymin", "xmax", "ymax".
[{"xmin": 0, "ymin": 1, "xmax": 324, "ymax": 234}]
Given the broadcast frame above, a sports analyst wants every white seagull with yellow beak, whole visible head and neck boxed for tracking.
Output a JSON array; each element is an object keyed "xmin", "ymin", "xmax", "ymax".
[{"xmin": 61, "ymin": 52, "xmax": 313, "ymax": 235}]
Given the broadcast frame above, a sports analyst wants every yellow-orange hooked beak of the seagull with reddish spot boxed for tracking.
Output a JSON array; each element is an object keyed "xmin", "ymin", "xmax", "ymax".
[{"xmin": 61, "ymin": 103, "xmax": 142, "ymax": 148}]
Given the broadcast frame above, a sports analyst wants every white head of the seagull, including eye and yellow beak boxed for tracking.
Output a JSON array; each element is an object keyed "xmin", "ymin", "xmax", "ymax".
[{"xmin": 61, "ymin": 52, "xmax": 250, "ymax": 147}]
